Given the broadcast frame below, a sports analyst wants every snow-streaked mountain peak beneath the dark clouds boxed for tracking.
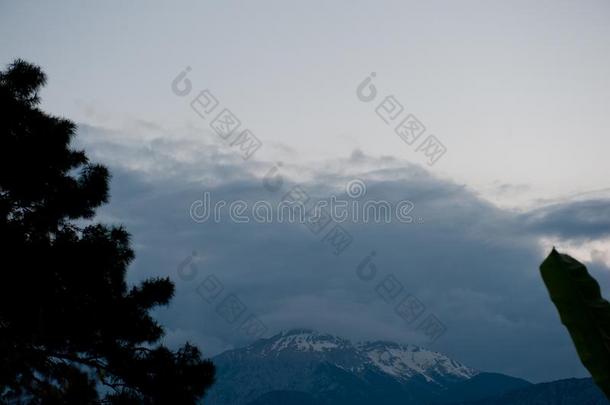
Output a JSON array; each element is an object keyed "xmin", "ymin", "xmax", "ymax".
[{"xmin": 204, "ymin": 329, "xmax": 531, "ymax": 405}]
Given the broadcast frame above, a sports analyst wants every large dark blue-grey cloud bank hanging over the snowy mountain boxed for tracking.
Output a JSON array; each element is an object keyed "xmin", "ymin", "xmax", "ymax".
[{"xmin": 75, "ymin": 122, "xmax": 610, "ymax": 381}]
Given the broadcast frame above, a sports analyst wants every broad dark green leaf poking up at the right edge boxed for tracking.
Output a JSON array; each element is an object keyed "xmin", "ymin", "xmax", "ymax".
[{"xmin": 540, "ymin": 248, "xmax": 610, "ymax": 399}]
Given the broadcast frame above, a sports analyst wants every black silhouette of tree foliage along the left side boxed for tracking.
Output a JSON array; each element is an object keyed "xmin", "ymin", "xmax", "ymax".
[{"xmin": 0, "ymin": 60, "xmax": 214, "ymax": 405}]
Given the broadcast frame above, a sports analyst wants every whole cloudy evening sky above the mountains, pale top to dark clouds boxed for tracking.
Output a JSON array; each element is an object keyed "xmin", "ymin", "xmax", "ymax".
[{"xmin": 0, "ymin": 1, "xmax": 610, "ymax": 381}]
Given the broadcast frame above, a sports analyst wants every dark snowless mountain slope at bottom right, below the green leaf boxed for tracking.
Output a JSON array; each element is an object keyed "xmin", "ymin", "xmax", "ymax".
[{"xmin": 460, "ymin": 378, "xmax": 610, "ymax": 405}]
